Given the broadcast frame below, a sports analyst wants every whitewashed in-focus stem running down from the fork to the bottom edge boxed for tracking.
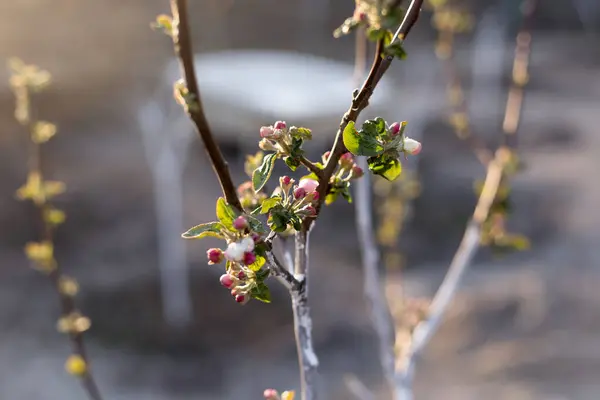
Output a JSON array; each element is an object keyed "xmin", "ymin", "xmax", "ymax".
[{"xmin": 291, "ymin": 229, "xmax": 319, "ymax": 400}]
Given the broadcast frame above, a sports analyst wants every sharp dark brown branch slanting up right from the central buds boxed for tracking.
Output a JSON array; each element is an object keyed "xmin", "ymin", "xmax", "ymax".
[{"xmin": 312, "ymin": 0, "xmax": 423, "ymax": 227}]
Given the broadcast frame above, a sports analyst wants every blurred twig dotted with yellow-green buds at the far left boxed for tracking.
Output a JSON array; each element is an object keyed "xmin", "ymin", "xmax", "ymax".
[{"xmin": 9, "ymin": 59, "xmax": 102, "ymax": 400}]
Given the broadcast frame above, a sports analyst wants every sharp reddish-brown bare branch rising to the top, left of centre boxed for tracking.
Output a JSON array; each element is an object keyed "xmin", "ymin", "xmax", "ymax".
[{"xmin": 166, "ymin": 0, "xmax": 243, "ymax": 211}]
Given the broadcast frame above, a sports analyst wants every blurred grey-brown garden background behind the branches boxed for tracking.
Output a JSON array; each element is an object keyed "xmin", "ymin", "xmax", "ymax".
[{"xmin": 0, "ymin": 0, "xmax": 600, "ymax": 400}]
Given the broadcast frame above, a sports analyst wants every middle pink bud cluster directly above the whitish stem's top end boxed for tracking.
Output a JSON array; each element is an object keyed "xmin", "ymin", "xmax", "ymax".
[{"xmin": 279, "ymin": 176, "xmax": 319, "ymax": 217}]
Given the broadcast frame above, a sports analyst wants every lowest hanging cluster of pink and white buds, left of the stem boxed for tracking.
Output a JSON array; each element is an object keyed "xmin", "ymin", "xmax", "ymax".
[{"xmin": 206, "ymin": 215, "xmax": 261, "ymax": 304}]
